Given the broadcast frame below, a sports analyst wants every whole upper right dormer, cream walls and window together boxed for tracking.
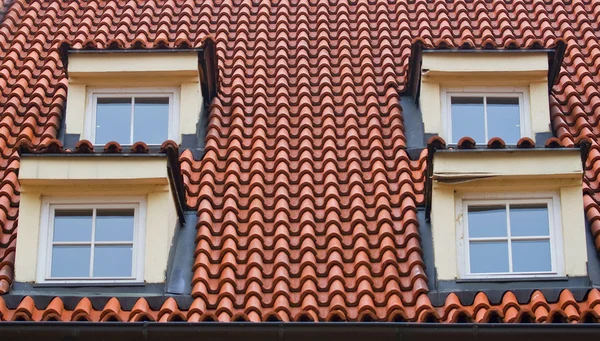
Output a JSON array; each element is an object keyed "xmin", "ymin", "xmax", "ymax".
[{"xmin": 418, "ymin": 50, "xmax": 558, "ymax": 145}]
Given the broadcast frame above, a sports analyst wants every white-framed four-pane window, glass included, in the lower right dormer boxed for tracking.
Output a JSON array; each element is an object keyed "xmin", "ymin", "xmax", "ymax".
[{"xmin": 457, "ymin": 192, "xmax": 564, "ymax": 278}]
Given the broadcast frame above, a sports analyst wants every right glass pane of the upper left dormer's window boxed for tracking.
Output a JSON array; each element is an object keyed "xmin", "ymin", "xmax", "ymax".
[{"xmin": 133, "ymin": 97, "xmax": 169, "ymax": 144}]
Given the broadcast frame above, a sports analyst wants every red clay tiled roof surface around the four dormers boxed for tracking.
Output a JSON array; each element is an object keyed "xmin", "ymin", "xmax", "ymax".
[{"xmin": 0, "ymin": 0, "xmax": 600, "ymax": 322}]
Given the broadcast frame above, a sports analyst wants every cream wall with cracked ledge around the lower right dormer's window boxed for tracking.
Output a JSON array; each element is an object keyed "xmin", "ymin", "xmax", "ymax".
[{"xmin": 431, "ymin": 151, "xmax": 587, "ymax": 280}]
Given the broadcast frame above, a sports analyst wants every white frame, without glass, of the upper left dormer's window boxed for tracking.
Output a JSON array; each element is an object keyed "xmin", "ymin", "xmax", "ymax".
[{"xmin": 84, "ymin": 87, "xmax": 179, "ymax": 145}]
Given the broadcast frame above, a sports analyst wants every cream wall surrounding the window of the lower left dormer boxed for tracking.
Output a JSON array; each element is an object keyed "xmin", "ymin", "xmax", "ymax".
[{"xmin": 15, "ymin": 157, "xmax": 177, "ymax": 283}]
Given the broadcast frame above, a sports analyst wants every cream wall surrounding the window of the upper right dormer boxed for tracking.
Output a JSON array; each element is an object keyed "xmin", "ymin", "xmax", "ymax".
[{"xmin": 419, "ymin": 52, "xmax": 551, "ymax": 142}]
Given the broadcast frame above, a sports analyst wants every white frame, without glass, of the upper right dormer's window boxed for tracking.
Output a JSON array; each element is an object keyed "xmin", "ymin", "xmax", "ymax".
[{"xmin": 442, "ymin": 87, "xmax": 531, "ymax": 144}]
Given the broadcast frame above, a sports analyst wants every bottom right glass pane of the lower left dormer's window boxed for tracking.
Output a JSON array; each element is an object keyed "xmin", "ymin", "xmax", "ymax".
[{"xmin": 94, "ymin": 245, "xmax": 133, "ymax": 277}]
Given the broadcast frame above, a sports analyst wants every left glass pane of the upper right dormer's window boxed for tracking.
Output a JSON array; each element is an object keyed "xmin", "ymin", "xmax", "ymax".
[{"xmin": 450, "ymin": 97, "xmax": 487, "ymax": 143}]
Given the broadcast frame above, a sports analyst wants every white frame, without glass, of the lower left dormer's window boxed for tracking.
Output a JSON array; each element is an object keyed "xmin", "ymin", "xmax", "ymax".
[{"xmin": 36, "ymin": 197, "xmax": 147, "ymax": 284}]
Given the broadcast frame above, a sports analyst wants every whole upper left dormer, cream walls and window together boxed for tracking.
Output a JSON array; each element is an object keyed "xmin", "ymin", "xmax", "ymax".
[{"xmin": 61, "ymin": 40, "xmax": 218, "ymax": 149}]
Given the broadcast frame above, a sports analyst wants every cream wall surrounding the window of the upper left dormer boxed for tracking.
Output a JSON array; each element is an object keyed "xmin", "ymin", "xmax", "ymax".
[{"xmin": 65, "ymin": 52, "xmax": 203, "ymax": 143}]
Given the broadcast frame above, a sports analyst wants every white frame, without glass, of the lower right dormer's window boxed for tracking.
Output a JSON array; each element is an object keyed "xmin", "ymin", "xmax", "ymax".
[{"xmin": 456, "ymin": 192, "xmax": 565, "ymax": 279}]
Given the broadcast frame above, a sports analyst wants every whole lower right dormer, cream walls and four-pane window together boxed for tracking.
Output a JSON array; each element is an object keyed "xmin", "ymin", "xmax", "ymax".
[{"xmin": 425, "ymin": 146, "xmax": 587, "ymax": 281}]
